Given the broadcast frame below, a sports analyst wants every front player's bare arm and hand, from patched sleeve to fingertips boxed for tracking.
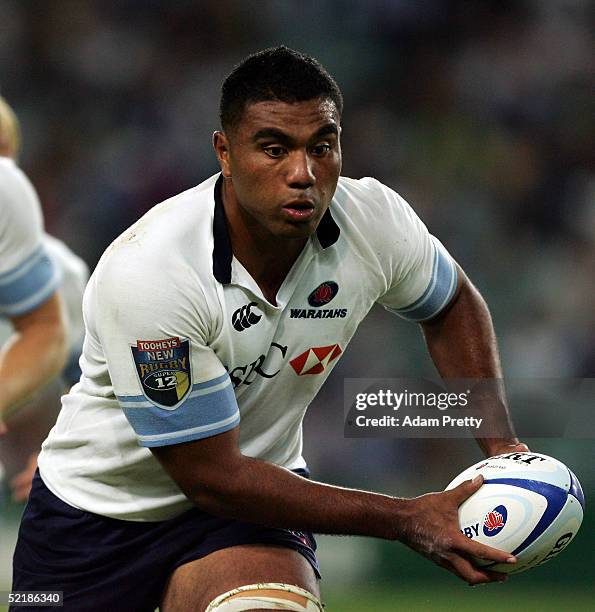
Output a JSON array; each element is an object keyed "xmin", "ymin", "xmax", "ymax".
[{"xmin": 151, "ymin": 420, "xmax": 510, "ymax": 584}]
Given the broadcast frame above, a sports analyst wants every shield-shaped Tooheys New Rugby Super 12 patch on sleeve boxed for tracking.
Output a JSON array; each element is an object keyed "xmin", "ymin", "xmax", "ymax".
[{"xmin": 130, "ymin": 337, "xmax": 192, "ymax": 408}]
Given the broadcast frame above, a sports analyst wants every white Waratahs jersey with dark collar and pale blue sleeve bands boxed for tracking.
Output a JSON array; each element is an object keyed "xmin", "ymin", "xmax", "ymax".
[{"xmin": 39, "ymin": 176, "xmax": 457, "ymax": 520}]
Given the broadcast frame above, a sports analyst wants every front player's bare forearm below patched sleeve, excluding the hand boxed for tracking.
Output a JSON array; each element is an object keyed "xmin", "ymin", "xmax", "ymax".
[{"xmin": 156, "ymin": 448, "xmax": 407, "ymax": 539}]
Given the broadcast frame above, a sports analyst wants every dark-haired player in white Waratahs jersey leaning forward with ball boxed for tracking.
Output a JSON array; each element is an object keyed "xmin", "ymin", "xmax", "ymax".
[{"xmin": 13, "ymin": 47, "xmax": 527, "ymax": 612}]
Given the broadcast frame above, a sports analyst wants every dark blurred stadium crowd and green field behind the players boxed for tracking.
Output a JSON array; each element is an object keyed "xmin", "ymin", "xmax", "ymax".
[{"xmin": 0, "ymin": 0, "xmax": 595, "ymax": 612}]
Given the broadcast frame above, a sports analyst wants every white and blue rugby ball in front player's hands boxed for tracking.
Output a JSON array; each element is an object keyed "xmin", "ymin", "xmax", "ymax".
[{"xmin": 446, "ymin": 453, "xmax": 585, "ymax": 574}]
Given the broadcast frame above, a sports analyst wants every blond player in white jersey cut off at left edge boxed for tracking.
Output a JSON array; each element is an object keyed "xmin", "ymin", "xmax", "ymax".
[{"xmin": 0, "ymin": 98, "xmax": 67, "ymax": 433}]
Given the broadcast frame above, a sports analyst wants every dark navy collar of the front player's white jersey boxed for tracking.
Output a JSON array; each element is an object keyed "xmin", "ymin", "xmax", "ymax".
[{"xmin": 213, "ymin": 174, "xmax": 341, "ymax": 285}]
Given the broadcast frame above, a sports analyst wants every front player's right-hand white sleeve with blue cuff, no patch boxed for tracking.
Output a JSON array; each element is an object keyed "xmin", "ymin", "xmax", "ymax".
[{"xmin": 378, "ymin": 179, "xmax": 460, "ymax": 322}]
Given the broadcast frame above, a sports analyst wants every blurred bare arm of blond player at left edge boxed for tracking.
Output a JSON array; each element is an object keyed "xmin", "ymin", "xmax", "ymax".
[{"xmin": 0, "ymin": 293, "xmax": 67, "ymax": 427}]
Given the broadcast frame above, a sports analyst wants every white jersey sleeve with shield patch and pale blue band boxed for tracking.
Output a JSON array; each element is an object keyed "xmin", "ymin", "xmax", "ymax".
[{"xmin": 92, "ymin": 251, "xmax": 240, "ymax": 448}]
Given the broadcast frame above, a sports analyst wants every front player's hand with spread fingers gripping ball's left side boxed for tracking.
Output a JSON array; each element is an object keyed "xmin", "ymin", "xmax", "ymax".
[{"xmin": 397, "ymin": 475, "xmax": 516, "ymax": 586}]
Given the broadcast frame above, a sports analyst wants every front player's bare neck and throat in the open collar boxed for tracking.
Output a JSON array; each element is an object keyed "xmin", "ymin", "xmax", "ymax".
[{"xmin": 222, "ymin": 181, "xmax": 308, "ymax": 303}]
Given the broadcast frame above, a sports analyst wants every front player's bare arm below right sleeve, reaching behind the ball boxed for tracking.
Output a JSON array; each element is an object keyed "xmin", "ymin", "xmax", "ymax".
[{"xmin": 421, "ymin": 266, "xmax": 529, "ymax": 457}]
